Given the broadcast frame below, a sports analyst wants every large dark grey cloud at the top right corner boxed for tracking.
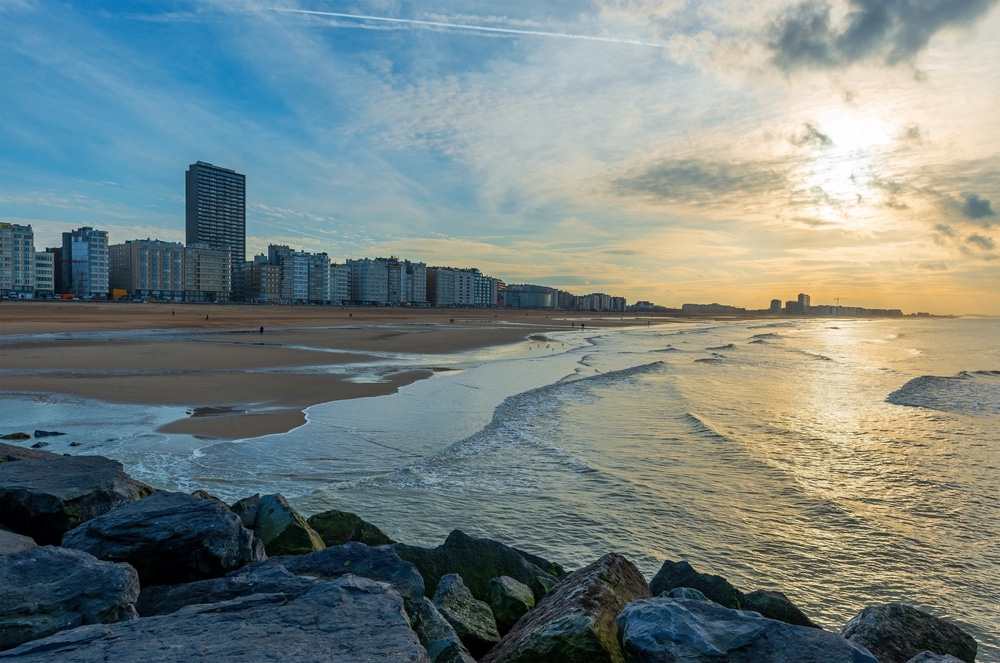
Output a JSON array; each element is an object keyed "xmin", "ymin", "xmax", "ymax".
[{"xmin": 767, "ymin": 0, "xmax": 997, "ymax": 71}]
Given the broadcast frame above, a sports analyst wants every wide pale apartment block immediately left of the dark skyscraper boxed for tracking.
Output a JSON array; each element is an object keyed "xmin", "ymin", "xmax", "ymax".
[{"xmin": 108, "ymin": 239, "xmax": 185, "ymax": 300}]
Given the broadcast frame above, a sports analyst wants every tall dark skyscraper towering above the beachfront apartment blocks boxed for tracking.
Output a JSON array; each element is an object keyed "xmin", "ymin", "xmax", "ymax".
[{"xmin": 185, "ymin": 161, "xmax": 247, "ymax": 301}]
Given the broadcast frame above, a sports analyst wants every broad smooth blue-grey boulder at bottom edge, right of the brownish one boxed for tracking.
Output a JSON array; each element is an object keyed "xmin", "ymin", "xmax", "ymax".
[{"xmin": 618, "ymin": 597, "xmax": 879, "ymax": 663}]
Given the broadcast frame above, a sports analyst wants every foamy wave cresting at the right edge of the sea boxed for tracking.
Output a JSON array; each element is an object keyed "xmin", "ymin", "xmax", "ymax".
[{"xmin": 885, "ymin": 371, "xmax": 1000, "ymax": 416}]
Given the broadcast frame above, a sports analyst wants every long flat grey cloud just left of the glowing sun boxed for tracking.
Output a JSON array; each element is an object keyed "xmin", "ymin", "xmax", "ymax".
[{"xmin": 612, "ymin": 159, "xmax": 786, "ymax": 202}]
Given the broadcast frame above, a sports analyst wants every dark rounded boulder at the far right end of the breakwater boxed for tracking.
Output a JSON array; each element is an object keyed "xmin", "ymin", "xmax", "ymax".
[{"xmin": 840, "ymin": 603, "xmax": 979, "ymax": 663}]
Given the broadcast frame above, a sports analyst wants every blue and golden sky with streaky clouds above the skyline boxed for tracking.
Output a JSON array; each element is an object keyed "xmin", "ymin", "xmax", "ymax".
[{"xmin": 0, "ymin": 0, "xmax": 1000, "ymax": 315}]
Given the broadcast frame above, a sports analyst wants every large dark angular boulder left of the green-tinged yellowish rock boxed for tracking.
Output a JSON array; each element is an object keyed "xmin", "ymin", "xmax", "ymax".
[{"xmin": 63, "ymin": 492, "xmax": 267, "ymax": 586}]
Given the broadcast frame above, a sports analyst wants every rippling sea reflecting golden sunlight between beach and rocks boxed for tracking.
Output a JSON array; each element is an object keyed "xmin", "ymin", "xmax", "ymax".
[{"xmin": 0, "ymin": 317, "xmax": 1000, "ymax": 662}]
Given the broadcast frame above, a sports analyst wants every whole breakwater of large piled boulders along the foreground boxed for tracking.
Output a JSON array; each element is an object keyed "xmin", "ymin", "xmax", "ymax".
[{"xmin": 0, "ymin": 444, "xmax": 976, "ymax": 663}]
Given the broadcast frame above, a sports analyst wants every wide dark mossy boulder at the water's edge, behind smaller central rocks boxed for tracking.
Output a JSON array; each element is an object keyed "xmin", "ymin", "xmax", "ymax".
[{"xmin": 393, "ymin": 530, "xmax": 556, "ymax": 600}]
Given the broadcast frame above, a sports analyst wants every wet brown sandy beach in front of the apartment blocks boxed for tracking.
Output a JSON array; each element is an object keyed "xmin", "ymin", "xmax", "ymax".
[{"xmin": 0, "ymin": 301, "xmax": 664, "ymax": 439}]
